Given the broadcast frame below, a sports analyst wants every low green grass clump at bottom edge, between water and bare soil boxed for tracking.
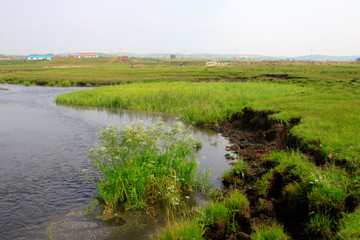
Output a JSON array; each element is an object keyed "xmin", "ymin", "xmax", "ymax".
[{"xmin": 156, "ymin": 190, "xmax": 250, "ymax": 239}]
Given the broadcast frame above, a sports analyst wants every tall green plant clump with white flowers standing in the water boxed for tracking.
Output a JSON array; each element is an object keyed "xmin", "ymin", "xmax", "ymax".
[{"xmin": 90, "ymin": 121, "xmax": 207, "ymax": 212}]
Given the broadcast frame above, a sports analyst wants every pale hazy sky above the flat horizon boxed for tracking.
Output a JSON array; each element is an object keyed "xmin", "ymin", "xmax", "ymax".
[{"xmin": 0, "ymin": 0, "xmax": 360, "ymax": 56}]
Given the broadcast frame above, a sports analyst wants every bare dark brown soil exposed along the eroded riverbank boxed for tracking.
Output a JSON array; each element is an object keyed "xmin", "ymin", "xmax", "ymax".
[{"xmin": 206, "ymin": 108, "xmax": 308, "ymax": 239}]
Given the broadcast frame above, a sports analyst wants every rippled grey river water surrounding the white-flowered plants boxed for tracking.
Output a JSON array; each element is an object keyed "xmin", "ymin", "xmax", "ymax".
[{"xmin": 0, "ymin": 84, "xmax": 228, "ymax": 239}]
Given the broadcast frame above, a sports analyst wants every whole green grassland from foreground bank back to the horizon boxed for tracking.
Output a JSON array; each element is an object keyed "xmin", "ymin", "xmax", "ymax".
[{"xmin": 0, "ymin": 57, "xmax": 360, "ymax": 239}]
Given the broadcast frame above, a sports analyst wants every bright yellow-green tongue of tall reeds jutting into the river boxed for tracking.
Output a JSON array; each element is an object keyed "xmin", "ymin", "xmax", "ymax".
[{"xmin": 56, "ymin": 82, "xmax": 309, "ymax": 124}]
